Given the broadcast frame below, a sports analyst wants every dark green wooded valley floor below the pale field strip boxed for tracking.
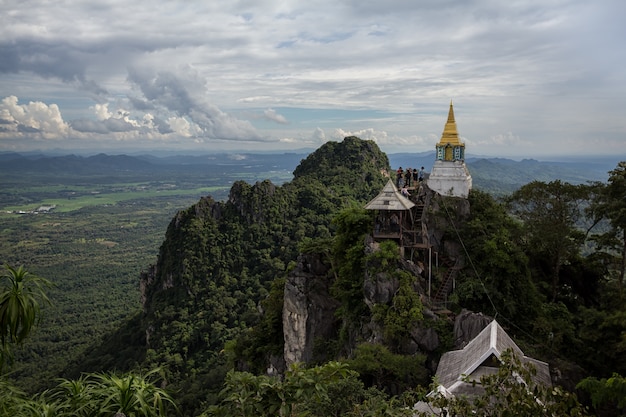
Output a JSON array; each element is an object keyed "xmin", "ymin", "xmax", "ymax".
[{"xmin": 0, "ymin": 197, "xmax": 198, "ymax": 392}]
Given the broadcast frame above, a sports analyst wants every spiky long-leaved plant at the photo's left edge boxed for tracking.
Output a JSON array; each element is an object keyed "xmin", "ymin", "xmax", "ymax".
[{"xmin": 0, "ymin": 264, "xmax": 52, "ymax": 370}]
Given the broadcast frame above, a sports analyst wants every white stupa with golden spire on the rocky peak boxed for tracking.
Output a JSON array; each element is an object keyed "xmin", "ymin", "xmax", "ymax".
[{"xmin": 427, "ymin": 101, "xmax": 472, "ymax": 198}]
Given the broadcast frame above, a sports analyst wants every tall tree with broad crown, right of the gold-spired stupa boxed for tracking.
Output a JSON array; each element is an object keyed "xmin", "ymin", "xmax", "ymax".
[{"xmin": 508, "ymin": 180, "xmax": 590, "ymax": 301}]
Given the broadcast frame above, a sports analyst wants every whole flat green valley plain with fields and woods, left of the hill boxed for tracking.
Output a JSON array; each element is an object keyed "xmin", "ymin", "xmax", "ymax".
[{"xmin": 0, "ymin": 158, "xmax": 291, "ymax": 392}]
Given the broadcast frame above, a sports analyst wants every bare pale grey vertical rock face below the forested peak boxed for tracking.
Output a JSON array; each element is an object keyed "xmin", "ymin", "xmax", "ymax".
[{"xmin": 283, "ymin": 250, "xmax": 339, "ymax": 366}]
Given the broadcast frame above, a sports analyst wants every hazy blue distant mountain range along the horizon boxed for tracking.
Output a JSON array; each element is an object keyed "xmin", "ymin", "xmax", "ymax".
[{"xmin": 0, "ymin": 152, "xmax": 620, "ymax": 194}]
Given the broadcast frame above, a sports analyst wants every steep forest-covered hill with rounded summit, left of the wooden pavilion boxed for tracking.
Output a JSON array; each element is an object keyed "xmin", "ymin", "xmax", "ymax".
[{"xmin": 68, "ymin": 137, "xmax": 390, "ymax": 407}]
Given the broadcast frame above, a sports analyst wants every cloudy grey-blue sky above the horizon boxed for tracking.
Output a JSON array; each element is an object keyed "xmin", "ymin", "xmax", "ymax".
[{"xmin": 0, "ymin": 0, "xmax": 626, "ymax": 157}]
